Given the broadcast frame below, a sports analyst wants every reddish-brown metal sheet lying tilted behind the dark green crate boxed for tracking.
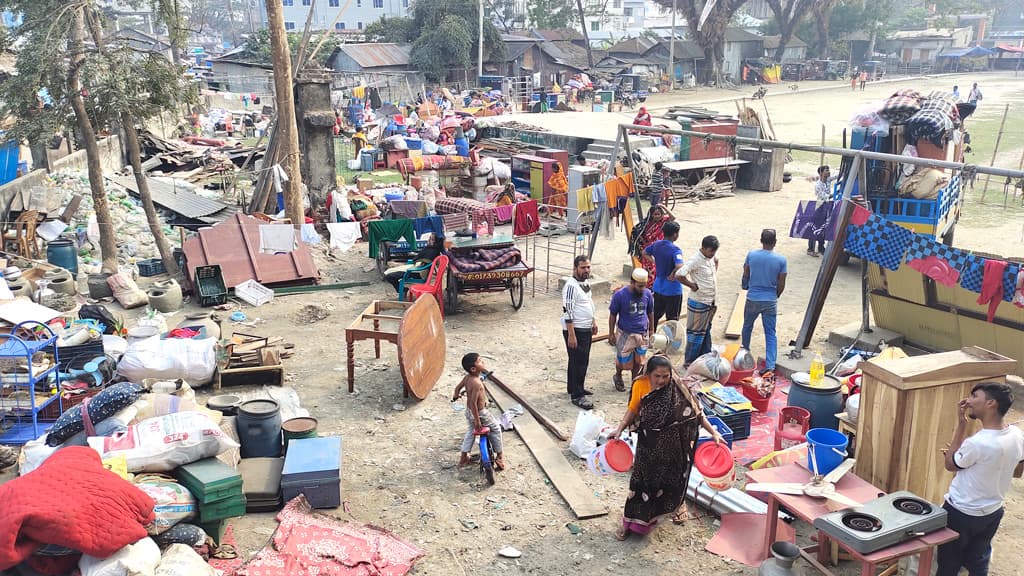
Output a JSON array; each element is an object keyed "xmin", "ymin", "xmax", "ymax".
[{"xmin": 182, "ymin": 214, "xmax": 319, "ymax": 288}]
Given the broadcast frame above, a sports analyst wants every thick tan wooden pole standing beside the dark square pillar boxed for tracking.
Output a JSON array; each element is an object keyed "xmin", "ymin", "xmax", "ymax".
[{"xmin": 266, "ymin": 0, "xmax": 305, "ymax": 229}]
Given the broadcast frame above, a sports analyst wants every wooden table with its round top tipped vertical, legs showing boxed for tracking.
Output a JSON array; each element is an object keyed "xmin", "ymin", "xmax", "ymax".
[{"xmin": 345, "ymin": 298, "xmax": 445, "ymax": 400}]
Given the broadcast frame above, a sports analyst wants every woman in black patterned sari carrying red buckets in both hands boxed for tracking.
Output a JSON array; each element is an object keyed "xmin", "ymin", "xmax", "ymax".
[{"xmin": 611, "ymin": 356, "xmax": 725, "ymax": 540}]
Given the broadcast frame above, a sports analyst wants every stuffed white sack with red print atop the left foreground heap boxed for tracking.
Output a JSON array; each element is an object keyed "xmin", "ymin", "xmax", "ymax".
[{"xmin": 89, "ymin": 412, "xmax": 239, "ymax": 472}]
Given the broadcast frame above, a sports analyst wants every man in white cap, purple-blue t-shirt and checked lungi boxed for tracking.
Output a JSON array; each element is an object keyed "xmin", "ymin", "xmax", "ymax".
[{"xmin": 608, "ymin": 268, "xmax": 654, "ymax": 392}]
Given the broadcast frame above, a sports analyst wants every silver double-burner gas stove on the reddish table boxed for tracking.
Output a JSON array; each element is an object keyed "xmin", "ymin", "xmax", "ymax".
[{"xmin": 814, "ymin": 492, "xmax": 946, "ymax": 554}]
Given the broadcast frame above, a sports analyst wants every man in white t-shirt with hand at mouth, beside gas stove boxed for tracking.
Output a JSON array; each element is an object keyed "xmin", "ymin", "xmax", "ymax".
[{"xmin": 937, "ymin": 382, "xmax": 1024, "ymax": 576}]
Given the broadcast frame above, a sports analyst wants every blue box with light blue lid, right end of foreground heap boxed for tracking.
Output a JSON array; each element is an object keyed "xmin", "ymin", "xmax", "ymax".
[{"xmin": 281, "ymin": 437, "xmax": 341, "ymax": 508}]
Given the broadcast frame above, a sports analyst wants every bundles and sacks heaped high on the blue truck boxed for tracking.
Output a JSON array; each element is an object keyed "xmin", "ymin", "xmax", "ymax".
[{"xmin": 850, "ymin": 89, "xmax": 976, "ymax": 199}]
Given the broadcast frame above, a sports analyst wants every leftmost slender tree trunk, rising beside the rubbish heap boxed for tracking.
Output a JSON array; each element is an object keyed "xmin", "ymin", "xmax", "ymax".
[{"xmin": 68, "ymin": 8, "xmax": 118, "ymax": 274}]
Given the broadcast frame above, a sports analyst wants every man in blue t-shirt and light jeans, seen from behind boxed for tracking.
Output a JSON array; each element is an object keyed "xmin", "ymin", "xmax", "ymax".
[{"xmin": 742, "ymin": 229, "xmax": 786, "ymax": 379}]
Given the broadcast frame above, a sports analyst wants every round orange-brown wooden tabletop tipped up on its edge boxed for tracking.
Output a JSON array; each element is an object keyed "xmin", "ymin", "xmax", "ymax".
[{"xmin": 398, "ymin": 295, "xmax": 446, "ymax": 400}]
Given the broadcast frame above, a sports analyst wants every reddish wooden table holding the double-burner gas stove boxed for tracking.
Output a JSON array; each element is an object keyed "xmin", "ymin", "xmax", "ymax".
[{"xmin": 746, "ymin": 463, "xmax": 958, "ymax": 576}]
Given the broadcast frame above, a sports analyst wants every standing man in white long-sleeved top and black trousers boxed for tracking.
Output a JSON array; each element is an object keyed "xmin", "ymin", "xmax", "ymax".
[{"xmin": 562, "ymin": 254, "xmax": 597, "ymax": 410}]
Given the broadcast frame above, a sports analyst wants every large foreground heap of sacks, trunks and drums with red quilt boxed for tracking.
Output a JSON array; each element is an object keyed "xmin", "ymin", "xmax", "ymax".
[{"xmin": 0, "ymin": 313, "xmax": 423, "ymax": 576}]
